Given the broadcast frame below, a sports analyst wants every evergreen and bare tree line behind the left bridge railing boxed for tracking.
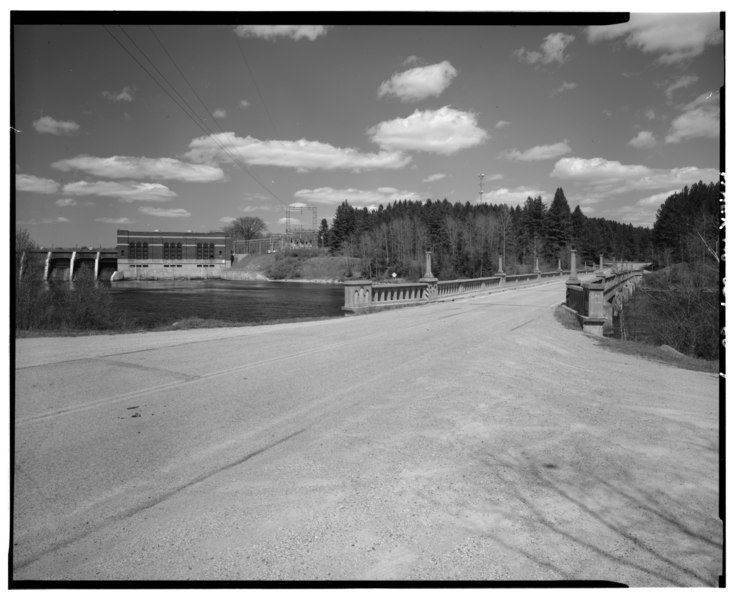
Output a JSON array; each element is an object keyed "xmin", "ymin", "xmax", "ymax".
[{"xmin": 320, "ymin": 188, "xmax": 652, "ymax": 279}]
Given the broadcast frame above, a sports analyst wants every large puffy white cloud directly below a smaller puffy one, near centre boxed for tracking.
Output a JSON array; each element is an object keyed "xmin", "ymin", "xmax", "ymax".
[{"xmin": 367, "ymin": 106, "xmax": 488, "ymax": 155}]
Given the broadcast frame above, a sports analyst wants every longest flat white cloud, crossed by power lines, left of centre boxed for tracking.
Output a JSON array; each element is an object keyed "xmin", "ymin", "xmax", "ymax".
[{"xmin": 185, "ymin": 132, "xmax": 411, "ymax": 171}]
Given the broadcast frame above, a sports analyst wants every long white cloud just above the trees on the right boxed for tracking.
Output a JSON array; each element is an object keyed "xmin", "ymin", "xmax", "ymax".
[{"xmin": 550, "ymin": 158, "xmax": 719, "ymax": 195}]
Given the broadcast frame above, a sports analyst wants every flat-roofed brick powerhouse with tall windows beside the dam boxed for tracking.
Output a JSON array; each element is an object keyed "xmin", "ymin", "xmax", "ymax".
[{"xmin": 114, "ymin": 229, "xmax": 231, "ymax": 280}]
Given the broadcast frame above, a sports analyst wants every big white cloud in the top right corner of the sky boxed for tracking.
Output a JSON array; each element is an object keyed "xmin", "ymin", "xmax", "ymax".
[{"xmin": 586, "ymin": 12, "xmax": 722, "ymax": 64}]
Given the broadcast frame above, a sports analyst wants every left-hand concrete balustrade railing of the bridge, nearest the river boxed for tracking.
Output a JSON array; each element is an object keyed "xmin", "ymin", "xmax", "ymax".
[{"xmin": 342, "ymin": 252, "xmax": 586, "ymax": 313}]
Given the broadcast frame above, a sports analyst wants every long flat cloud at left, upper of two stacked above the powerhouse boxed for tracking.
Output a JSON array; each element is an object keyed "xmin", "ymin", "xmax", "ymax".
[{"xmin": 51, "ymin": 155, "xmax": 224, "ymax": 182}]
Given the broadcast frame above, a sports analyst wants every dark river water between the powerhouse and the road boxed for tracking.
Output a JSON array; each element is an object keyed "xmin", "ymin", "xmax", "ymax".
[{"xmin": 110, "ymin": 279, "xmax": 344, "ymax": 328}]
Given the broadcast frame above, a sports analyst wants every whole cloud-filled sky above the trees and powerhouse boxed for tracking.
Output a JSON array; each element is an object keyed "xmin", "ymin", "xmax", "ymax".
[{"xmin": 12, "ymin": 12, "xmax": 725, "ymax": 247}]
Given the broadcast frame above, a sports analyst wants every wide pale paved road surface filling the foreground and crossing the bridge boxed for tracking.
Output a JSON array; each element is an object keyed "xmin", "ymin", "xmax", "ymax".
[{"xmin": 13, "ymin": 281, "xmax": 722, "ymax": 586}]
